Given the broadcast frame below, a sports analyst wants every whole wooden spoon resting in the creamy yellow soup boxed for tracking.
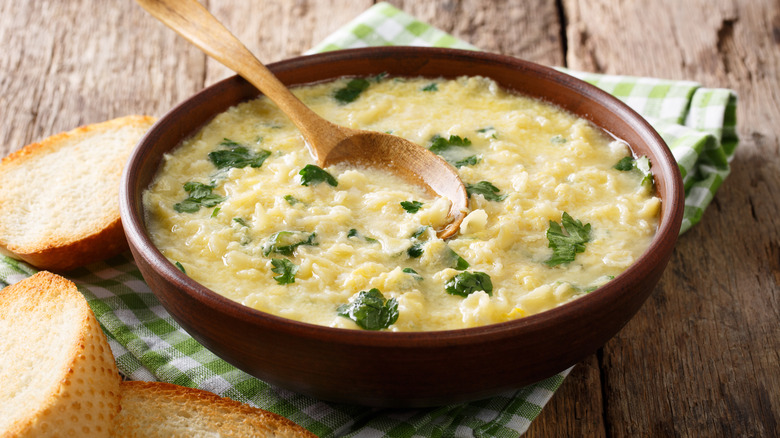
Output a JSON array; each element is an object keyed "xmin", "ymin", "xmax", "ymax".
[{"xmin": 136, "ymin": 0, "xmax": 468, "ymax": 239}]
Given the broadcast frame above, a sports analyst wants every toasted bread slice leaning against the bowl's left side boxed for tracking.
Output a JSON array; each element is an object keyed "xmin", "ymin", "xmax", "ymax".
[{"xmin": 0, "ymin": 116, "xmax": 155, "ymax": 271}]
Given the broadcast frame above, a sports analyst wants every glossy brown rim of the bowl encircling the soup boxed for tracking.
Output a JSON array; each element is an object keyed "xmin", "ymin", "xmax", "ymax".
[{"xmin": 120, "ymin": 46, "xmax": 684, "ymax": 347}]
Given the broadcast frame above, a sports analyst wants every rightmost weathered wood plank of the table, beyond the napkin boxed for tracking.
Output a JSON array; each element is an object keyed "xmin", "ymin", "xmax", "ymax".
[{"xmin": 564, "ymin": 0, "xmax": 780, "ymax": 436}]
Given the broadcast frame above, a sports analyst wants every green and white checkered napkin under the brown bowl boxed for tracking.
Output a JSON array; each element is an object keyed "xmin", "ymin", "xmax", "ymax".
[{"xmin": 0, "ymin": 3, "xmax": 737, "ymax": 437}]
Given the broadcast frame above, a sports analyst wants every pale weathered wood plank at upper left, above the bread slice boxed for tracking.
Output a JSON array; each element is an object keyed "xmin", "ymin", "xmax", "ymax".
[{"xmin": 0, "ymin": 0, "xmax": 204, "ymax": 156}]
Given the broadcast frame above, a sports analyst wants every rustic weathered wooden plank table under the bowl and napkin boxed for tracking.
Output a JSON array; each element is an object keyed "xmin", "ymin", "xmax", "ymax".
[{"xmin": 0, "ymin": 0, "xmax": 780, "ymax": 437}]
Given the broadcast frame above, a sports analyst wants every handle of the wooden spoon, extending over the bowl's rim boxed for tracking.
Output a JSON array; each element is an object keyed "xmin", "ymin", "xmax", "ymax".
[{"xmin": 136, "ymin": 0, "xmax": 340, "ymax": 145}]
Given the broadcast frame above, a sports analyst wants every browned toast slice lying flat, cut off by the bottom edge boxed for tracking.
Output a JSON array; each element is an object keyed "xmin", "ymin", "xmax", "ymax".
[{"xmin": 114, "ymin": 382, "xmax": 316, "ymax": 438}]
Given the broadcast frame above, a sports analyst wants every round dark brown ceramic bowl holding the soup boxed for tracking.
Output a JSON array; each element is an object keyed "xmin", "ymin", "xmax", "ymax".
[{"xmin": 121, "ymin": 47, "xmax": 683, "ymax": 407}]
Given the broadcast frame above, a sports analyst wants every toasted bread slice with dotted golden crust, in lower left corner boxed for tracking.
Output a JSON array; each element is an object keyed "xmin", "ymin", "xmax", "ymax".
[{"xmin": 0, "ymin": 272, "xmax": 121, "ymax": 438}]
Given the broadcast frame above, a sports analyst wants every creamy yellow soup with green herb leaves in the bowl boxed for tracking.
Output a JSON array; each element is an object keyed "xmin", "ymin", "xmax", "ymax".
[{"xmin": 144, "ymin": 76, "xmax": 660, "ymax": 331}]
